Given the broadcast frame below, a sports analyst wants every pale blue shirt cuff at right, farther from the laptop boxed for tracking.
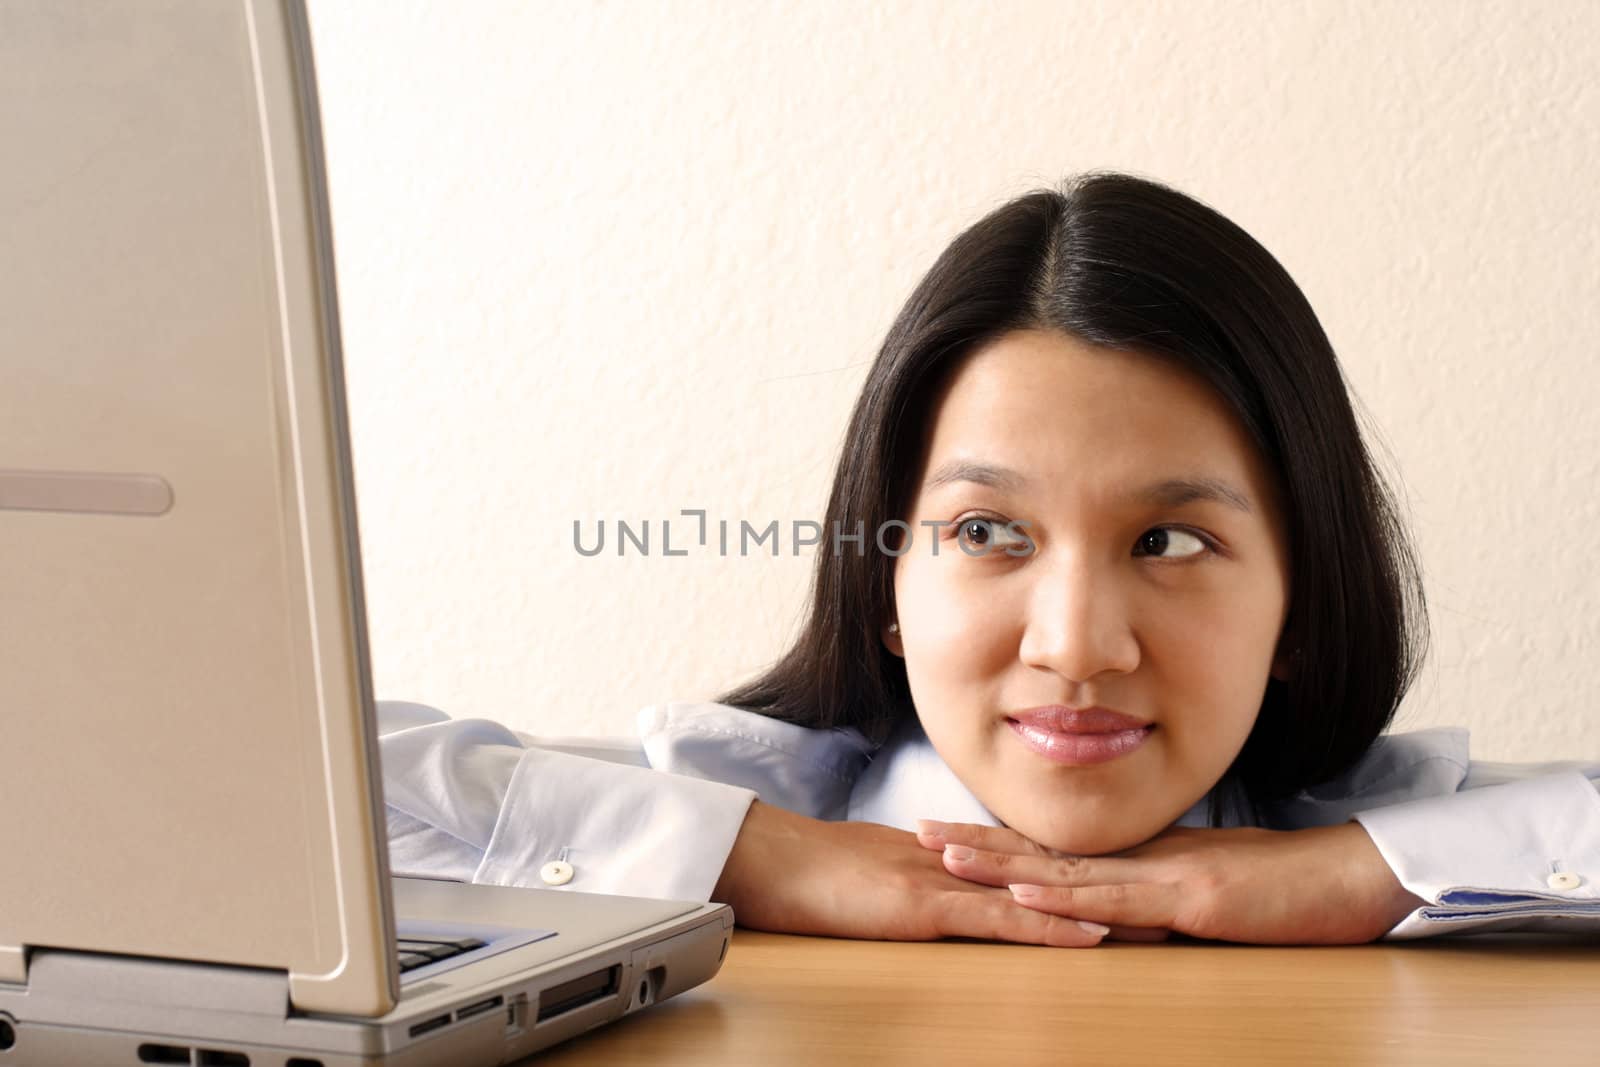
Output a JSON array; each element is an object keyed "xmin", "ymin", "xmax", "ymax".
[{"xmin": 1352, "ymin": 771, "xmax": 1600, "ymax": 941}]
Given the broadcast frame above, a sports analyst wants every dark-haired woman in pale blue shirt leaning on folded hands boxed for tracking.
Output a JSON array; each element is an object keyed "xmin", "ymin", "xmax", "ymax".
[{"xmin": 384, "ymin": 174, "xmax": 1600, "ymax": 945}]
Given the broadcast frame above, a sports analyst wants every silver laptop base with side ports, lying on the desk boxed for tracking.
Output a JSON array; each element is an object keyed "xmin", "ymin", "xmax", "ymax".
[{"xmin": 0, "ymin": 878, "xmax": 733, "ymax": 1067}]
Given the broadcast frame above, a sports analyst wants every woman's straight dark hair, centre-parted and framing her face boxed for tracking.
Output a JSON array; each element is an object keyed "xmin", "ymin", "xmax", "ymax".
[{"xmin": 718, "ymin": 171, "xmax": 1427, "ymax": 824}]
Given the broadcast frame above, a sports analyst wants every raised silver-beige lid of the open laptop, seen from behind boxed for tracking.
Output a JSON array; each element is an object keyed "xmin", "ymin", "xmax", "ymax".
[{"xmin": 0, "ymin": 0, "xmax": 398, "ymax": 1014}]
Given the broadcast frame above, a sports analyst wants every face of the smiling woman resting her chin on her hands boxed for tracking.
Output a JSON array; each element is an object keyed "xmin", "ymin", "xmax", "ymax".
[{"xmin": 885, "ymin": 331, "xmax": 1290, "ymax": 854}]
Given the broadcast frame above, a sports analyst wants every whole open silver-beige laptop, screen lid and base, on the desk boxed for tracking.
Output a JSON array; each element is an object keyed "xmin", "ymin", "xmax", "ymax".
[{"xmin": 0, "ymin": 0, "xmax": 733, "ymax": 1067}]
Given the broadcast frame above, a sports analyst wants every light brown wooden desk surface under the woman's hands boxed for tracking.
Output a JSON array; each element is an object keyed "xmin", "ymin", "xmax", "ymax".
[{"xmin": 526, "ymin": 929, "xmax": 1600, "ymax": 1067}]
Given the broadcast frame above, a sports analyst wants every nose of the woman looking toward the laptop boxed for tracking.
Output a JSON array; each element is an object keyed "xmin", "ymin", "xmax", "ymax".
[{"xmin": 1019, "ymin": 561, "xmax": 1141, "ymax": 681}]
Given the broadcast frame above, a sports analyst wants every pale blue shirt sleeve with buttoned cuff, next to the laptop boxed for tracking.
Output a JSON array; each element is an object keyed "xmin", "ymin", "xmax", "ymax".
[{"xmin": 378, "ymin": 701, "xmax": 757, "ymax": 901}]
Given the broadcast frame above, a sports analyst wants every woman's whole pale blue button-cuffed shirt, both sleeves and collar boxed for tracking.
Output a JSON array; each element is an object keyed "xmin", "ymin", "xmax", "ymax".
[{"xmin": 378, "ymin": 701, "xmax": 1600, "ymax": 941}]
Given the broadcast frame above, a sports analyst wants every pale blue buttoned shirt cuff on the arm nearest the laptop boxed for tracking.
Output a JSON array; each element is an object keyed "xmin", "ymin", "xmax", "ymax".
[{"xmin": 472, "ymin": 749, "xmax": 755, "ymax": 901}]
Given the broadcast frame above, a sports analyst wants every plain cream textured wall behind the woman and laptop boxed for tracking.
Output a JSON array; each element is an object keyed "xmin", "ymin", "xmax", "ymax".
[{"xmin": 302, "ymin": 0, "xmax": 1600, "ymax": 760}]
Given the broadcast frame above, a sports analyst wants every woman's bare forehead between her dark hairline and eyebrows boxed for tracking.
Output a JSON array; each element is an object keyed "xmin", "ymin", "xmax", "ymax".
[{"xmin": 918, "ymin": 330, "xmax": 1274, "ymax": 510}]
